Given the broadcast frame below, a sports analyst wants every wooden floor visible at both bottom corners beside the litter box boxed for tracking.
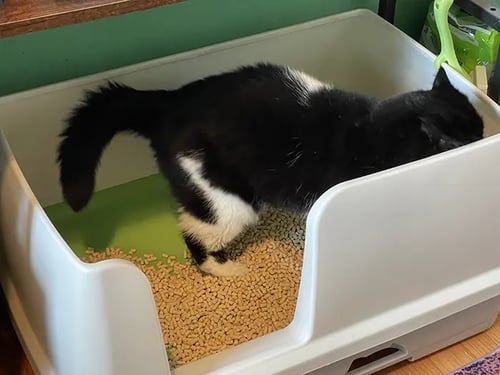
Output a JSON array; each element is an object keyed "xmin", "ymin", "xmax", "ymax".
[{"xmin": 0, "ymin": 293, "xmax": 500, "ymax": 375}]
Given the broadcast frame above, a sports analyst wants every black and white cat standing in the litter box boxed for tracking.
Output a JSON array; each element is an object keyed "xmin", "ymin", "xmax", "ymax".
[{"xmin": 58, "ymin": 64, "xmax": 483, "ymax": 276}]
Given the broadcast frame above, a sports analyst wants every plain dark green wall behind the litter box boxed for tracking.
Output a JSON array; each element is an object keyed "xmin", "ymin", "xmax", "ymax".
[{"xmin": 0, "ymin": 0, "xmax": 431, "ymax": 95}]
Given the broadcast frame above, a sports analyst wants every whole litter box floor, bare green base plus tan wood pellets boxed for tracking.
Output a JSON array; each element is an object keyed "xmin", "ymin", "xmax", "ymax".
[{"xmin": 46, "ymin": 176, "xmax": 305, "ymax": 367}]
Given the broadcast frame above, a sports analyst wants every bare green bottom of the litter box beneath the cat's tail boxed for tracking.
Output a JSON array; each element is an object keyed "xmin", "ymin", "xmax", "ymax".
[{"xmin": 45, "ymin": 175, "xmax": 185, "ymax": 261}]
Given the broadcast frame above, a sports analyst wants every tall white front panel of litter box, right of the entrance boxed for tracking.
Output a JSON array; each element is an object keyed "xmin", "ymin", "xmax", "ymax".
[{"xmin": 296, "ymin": 130, "xmax": 500, "ymax": 346}]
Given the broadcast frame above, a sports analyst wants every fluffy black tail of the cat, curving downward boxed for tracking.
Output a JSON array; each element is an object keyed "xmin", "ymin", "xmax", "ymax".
[{"xmin": 58, "ymin": 83, "xmax": 169, "ymax": 211}]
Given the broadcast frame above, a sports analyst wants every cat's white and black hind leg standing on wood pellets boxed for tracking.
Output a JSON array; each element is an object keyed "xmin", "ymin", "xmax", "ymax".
[{"xmin": 178, "ymin": 155, "xmax": 258, "ymax": 276}]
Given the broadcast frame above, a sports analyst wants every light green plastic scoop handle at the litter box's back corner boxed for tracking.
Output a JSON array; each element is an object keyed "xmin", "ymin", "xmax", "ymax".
[{"xmin": 434, "ymin": 0, "xmax": 472, "ymax": 82}]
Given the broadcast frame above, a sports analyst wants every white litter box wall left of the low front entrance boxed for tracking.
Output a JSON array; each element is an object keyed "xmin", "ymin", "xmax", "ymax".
[{"xmin": 0, "ymin": 130, "xmax": 170, "ymax": 375}]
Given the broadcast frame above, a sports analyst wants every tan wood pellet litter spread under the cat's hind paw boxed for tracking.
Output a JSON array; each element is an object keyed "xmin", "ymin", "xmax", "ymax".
[{"xmin": 83, "ymin": 210, "xmax": 305, "ymax": 367}]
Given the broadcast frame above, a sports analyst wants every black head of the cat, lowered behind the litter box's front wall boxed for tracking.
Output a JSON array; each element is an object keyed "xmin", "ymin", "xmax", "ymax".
[{"xmin": 375, "ymin": 68, "xmax": 484, "ymax": 168}]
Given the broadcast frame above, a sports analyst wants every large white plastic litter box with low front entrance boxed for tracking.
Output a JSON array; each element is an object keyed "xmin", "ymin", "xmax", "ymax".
[{"xmin": 0, "ymin": 10, "xmax": 500, "ymax": 375}]
